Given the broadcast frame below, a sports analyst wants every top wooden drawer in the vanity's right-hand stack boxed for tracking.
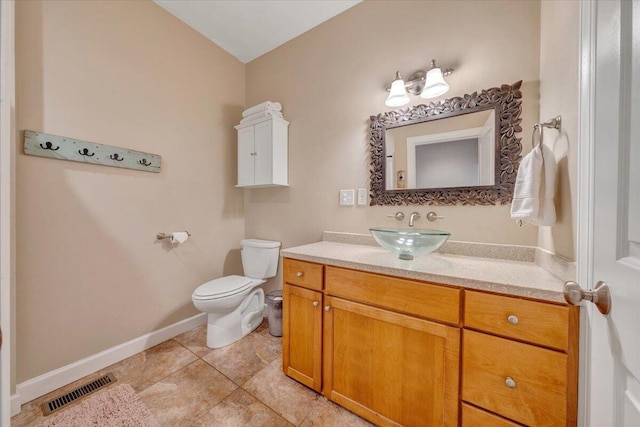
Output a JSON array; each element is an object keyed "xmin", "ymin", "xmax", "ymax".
[{"xmin": 464, "ymin": 291, "xmax": 570, "ymax": 351}]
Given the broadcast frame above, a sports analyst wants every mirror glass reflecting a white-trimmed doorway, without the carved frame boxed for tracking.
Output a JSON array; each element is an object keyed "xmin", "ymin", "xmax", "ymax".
[{"xmin": 385, "ymin": 109, "xmax": 496, "ymax": 190}]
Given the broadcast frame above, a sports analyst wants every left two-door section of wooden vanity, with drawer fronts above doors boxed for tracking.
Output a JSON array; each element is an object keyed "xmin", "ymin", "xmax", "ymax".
[{"xmin": 283, "ymin": 258, "xmax": 461, "ymax": 427}]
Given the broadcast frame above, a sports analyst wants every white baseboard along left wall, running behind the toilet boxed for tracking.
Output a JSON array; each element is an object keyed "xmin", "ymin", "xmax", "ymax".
[{"xmin": 11, "ymin": 313, "xmax": 207, "ymax": 415}]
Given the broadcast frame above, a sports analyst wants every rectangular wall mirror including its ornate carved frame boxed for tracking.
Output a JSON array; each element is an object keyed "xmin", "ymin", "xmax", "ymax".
[{"xmin": 371, "ymin": 82, "xmax": 522, "ymax": 205}]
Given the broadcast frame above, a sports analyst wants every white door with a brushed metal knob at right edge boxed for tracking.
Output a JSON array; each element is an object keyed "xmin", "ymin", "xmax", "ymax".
[{"xmin": 578, "ymin": 0, "xmax": 640, "ymax": 427}]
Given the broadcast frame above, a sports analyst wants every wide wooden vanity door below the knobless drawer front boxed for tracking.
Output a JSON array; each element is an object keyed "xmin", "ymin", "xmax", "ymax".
[{"xmin": 323, "ymin": 297, "xmax": 460, "ymax": 427}]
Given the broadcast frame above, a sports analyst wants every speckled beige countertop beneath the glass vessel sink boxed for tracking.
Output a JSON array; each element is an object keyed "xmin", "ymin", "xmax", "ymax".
[{"xmin": 281, "ymin": 241, "xmax": 564, "ymax": 303}]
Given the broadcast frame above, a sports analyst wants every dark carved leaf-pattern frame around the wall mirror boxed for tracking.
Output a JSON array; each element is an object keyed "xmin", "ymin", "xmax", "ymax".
[{"xmin": 370, "ymin": 81, "xmax": 522, "ymax": 206}]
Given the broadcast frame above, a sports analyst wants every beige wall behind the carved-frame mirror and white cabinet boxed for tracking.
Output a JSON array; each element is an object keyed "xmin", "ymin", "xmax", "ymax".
[{"xmin": 245, "ymin": 1, "xmax": 540, "ymax": 292}]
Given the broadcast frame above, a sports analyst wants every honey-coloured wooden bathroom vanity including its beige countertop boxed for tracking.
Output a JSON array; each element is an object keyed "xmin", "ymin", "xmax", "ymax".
[{"xmin": 282, "ymin": 241, "xmax": 579, "ymax": 427}]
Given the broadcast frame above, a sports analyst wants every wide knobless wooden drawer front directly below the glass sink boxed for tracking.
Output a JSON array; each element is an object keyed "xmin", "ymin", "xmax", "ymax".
[{"xmin": 325, "ymin": 266, "xmax": 461, "ymax": 325}]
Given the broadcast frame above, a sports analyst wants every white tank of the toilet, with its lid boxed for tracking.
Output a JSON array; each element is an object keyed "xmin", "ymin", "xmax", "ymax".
[{"xmin": 240, "ymin": 239, "xmax": 280, "ymax": 279}]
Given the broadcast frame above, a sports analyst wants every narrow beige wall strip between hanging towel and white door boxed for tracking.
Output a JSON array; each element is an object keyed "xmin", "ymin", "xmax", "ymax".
[{"xmin": 538, "ymin": 0, "xmax": 580, "ymax": 260}]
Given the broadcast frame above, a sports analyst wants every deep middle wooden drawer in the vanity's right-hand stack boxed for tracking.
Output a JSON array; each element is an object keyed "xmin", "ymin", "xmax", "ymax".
[{"xmin": 462, "ymin": 330, "xmax": 568, "ymax": 426}]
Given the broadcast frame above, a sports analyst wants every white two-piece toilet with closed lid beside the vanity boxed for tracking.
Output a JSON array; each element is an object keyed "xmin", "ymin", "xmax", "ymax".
[{"xmin": 191, "ymin": 239, "xmax": 280, "ymax": 348}]
